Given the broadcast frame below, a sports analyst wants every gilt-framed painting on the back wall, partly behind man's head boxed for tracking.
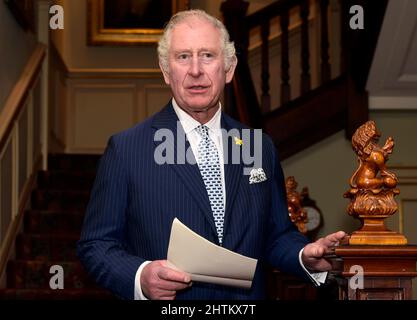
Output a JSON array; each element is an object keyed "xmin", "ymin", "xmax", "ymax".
[{"xmin": 87, "ymin": 0, "xmax": 188, "ymax": 46}]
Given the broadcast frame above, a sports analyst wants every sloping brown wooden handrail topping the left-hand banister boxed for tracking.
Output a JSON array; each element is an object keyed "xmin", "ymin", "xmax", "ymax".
[{"xmin": 0, "ymin": 43, "xmax": 46, "ymax": 150}]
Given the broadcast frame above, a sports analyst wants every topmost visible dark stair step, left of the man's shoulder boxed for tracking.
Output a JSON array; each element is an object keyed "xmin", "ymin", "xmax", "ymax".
[{"xmin": 48, "ymin": 154, "xmax": 101, "ymax": 171}]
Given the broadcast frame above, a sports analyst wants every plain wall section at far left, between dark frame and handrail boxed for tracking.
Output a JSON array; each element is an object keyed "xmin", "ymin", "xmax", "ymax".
[{"xmin": 0, "ymin": 1, "xmax": 36, "ymax": 111}]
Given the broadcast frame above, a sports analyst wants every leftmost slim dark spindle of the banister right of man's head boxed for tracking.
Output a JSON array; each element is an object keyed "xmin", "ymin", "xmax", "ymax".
[{"xmin": 261, "ymin": 20, "xmax": 271, "ymax": 113}]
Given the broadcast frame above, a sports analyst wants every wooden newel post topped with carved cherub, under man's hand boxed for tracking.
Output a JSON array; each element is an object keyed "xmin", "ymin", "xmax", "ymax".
[{"xmin": 335, "ymin": 121, "xmax": 417, "ymax": 300}]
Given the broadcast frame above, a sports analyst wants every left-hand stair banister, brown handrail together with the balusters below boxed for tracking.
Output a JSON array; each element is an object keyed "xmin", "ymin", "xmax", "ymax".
[{"xmin": 0, "ymin": 44, "xmax": 47, "ymax": 277}]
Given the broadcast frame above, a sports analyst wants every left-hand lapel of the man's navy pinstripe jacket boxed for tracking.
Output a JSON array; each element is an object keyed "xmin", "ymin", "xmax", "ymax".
[{"xmin": 152, "ymin": 103, "xmax": 217, "ymax": 236}]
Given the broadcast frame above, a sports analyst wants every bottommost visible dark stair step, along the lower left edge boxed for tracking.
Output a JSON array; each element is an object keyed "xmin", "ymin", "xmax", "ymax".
[{"xmin": 0, "ymin": 287, "xmax": 115, "ymax": 300}]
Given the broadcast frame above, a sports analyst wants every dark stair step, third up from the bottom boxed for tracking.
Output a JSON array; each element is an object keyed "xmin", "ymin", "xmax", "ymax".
[{"xmin": 16, "ymin": 233, "xmax": 79, "ymax": 261}]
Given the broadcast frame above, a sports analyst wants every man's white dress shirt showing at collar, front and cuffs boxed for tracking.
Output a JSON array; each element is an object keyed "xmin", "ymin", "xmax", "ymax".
[{"xmin": 135, "ymin": 98, "xmax": 327, "ymax": 300}]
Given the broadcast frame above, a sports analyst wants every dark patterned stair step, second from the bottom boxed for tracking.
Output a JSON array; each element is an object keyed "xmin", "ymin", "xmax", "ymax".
[{"xmin": 7, "ymin": 260, "xmax": 99, "ymax": 289}]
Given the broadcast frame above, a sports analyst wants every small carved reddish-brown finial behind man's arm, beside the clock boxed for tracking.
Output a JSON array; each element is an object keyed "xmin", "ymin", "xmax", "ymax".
[{"xmin": 285, "ymin": 176, "xmax": 307, "ymax": 234}]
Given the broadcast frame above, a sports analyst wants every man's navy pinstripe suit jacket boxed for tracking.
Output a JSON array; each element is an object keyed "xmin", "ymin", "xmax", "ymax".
[{"xmin": 77, "ymin": 103, "xmax": 308, "ymax": 299}]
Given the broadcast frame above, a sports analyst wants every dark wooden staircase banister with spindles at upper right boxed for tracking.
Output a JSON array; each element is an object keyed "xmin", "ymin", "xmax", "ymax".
[{"xmin": 221, "ymin": 0, "xmax": 387, "ymax": 160}]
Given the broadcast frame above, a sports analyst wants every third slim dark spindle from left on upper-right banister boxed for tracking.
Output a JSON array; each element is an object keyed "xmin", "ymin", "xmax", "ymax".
[{"xmin": 300, "ymin": 0, "xmax": 311, "ymax": 94}]
